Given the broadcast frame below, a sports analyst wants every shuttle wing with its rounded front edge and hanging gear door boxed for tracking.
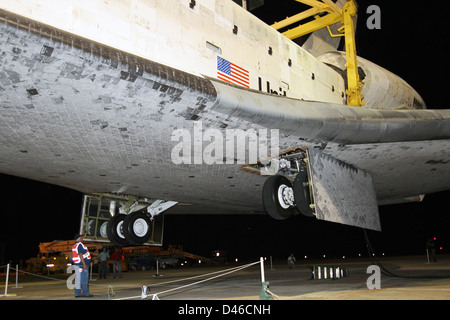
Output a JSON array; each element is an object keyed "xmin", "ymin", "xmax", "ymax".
[{"xmin": 209, "ymin": 81, "xmax": 450, "ymax": 230}]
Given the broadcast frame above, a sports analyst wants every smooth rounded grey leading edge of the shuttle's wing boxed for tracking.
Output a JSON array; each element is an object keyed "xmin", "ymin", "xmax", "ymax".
[{"xmin": 211, "ymin": 80, "xmax": 450, "ymax": 144}]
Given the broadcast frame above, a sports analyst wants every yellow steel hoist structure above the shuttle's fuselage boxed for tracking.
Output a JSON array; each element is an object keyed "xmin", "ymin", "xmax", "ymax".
[{"xmin": 272, "ymin": 0, "xmax": 364, "ymax": 107}]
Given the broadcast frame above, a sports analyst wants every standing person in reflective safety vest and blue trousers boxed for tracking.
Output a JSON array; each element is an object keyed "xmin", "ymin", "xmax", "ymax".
[{"xmin": 72, "ymin": 234, "xmax": 93, "ymax": 298}]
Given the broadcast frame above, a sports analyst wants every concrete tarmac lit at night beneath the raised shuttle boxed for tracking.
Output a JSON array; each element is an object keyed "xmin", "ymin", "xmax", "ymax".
[{"xmin": 0, "ymin": 255, "xmax": 450, "ymax": 301}]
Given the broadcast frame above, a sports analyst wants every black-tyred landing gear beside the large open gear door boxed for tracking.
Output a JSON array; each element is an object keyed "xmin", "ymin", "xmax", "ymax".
[{"xmin": 263, "ymin": 151, "xmax": 315, "ymax": 220}]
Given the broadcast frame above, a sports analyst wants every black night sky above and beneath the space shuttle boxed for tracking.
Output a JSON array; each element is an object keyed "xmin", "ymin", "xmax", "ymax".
[{"xmin": 0, "ymin": 0, "xmax": 450, "ymax": 262}]
